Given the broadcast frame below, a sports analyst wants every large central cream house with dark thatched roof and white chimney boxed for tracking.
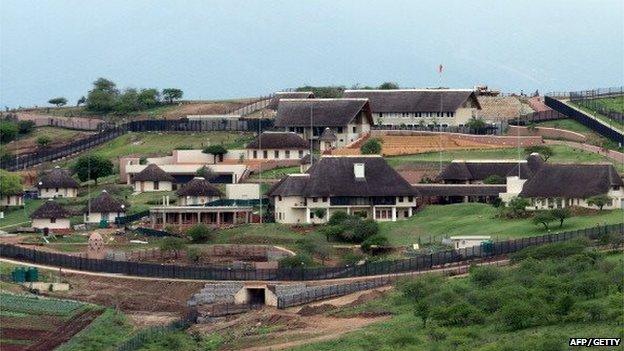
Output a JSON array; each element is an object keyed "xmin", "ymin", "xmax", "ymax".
[{"xmin": 268, "ymin": 155, "xmax": 417, "ymax": 224}]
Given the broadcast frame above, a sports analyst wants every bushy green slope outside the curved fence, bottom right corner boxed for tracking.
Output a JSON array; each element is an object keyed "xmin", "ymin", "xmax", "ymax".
[{"xmin": 292, "ymin": 245, "xmax": 624, "ymax": 351}]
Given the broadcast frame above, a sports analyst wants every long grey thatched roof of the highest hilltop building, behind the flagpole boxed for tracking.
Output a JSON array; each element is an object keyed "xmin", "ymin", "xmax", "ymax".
[{"xmin": 343, "ymin": 89, "xmax": 481, "ymax": 113}]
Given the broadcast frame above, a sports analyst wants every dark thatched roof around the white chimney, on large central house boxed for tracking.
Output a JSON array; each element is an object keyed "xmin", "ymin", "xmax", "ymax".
[{"xmin": 269, "ymin": 156, "xmax": 416, "ymax": 197}]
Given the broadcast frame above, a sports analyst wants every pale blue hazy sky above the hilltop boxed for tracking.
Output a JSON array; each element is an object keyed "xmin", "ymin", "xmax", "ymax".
[{"xmin": 0, "ymin": 0, "xmax": 624, "ymax": 107}]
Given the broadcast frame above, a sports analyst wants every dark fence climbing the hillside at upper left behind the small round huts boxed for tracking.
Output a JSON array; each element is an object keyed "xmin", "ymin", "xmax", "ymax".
[{"xmin": 0, "ymin": 118, "xmax": 273, "ymax": 171}]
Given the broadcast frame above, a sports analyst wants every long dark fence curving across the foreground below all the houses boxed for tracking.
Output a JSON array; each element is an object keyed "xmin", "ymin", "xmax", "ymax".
[{"xmin": 0, "ymin": 223, "xmax": 624, "ymax": 281}]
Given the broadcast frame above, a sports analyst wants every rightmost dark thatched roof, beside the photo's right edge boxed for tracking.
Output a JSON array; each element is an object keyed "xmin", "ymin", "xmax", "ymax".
[{"xmin": 520, "ymin": 164, "xmax": 624, "ymax": 199}]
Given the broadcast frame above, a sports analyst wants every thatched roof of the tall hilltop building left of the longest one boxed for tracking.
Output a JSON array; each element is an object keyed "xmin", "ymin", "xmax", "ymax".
[{"xmin": 275, "ymin": 99, "xmax": 374, "ymax": 127}]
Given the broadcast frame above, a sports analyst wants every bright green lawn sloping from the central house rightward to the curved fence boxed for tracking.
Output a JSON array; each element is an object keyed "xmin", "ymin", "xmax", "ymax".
[{"xmin": 379, "ymin": 203, "xmax": 624, "ymax": 245}]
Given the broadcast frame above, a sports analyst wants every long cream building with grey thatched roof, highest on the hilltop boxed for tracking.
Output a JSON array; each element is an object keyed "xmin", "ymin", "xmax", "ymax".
[{"xmin": 344, "ymin": 89, "xmax": 481, "ymax": 127}]
